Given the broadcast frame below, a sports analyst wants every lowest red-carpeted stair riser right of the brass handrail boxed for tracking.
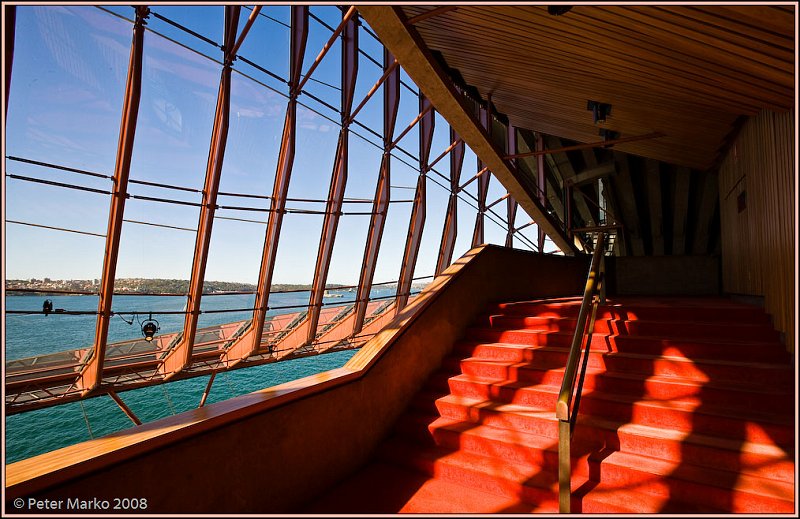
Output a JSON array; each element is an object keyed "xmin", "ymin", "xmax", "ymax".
[{"xmin": 588, "ymin": 462, "xmax": 794, "ymax": 513}]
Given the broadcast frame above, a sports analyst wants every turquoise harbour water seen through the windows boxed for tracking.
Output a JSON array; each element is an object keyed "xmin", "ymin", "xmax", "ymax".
[{"xmin": 5, "ymin": 289, "xmax": 391, "ymax": 463}]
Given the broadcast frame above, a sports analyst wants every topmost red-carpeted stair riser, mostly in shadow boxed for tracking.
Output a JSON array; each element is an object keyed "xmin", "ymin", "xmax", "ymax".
[{"xmin": 490, "ymin": 303, "xmax": 772, "ymax": 324}]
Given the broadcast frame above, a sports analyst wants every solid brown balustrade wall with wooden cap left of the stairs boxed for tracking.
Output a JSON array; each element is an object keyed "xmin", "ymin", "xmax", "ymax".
[{"xmin": 6, "ymin": 246, "xmax": 588, "ymax": 514}]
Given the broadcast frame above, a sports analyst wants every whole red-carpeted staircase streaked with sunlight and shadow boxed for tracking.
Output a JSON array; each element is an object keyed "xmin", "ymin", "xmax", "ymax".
[{"xmin": 305, "ymin": 298, "xmax": 795, "ymax": 513}]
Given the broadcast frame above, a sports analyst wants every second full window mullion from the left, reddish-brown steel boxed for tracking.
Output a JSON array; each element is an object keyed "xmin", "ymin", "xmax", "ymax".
[{"xmin": 158, "ymin": 5, "xmax": 241, "ymax": 380}]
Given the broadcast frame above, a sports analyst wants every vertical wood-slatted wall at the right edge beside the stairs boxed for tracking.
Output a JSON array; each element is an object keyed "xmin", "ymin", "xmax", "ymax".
[{"xmin": 719, "ymin": 111, "xmax": 796, "ymax": 351}]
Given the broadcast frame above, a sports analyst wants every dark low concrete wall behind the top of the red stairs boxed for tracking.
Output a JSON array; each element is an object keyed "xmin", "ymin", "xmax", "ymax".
[{"xmin": 606, "ymin": 256, "xmax": 720, "ymax": 296}]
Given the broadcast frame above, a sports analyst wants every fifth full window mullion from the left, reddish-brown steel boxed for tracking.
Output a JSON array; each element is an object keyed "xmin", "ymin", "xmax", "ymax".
[{"xmin": 353, "ymin": 49, "xmax": 400, "ymax": 336}]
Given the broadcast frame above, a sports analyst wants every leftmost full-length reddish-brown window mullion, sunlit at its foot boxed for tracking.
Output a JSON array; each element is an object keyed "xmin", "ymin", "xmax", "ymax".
[{"xmin": 77, "ymin": 6, "xmax": 149, "ymax": 395}]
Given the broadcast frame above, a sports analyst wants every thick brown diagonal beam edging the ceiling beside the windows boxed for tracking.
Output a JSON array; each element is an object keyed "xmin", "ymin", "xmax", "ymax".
[{"xmin": 358, "ymin": 5, "xmax": 577, "ymax": 255}]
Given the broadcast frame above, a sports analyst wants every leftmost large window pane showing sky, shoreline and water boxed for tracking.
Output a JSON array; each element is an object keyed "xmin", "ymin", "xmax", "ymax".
[{"xmin": 4, "ymin": 6, "xmax": 131, "ymax": 359}]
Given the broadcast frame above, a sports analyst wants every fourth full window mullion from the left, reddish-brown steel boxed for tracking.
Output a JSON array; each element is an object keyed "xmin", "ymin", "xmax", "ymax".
[{"xmin": 306, "ymin": 8, "xmax": 358, "ymax": 344}]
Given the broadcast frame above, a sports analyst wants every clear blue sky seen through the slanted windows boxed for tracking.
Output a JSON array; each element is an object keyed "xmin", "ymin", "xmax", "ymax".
[{"xmin": 5, "ymin": 6, "xmax": 535, "ymax": 284}]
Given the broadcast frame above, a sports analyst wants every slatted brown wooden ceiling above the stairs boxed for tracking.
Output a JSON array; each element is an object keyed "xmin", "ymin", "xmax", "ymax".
[{"xmin": 398, "ymin": 4, "xmax": 795, "ymax": 171}]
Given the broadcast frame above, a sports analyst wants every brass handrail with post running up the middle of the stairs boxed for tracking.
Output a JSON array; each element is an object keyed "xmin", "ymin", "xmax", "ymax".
[{"xmin": 556, "ymin": 231, "xmax": 606, "ymax": 513}]
